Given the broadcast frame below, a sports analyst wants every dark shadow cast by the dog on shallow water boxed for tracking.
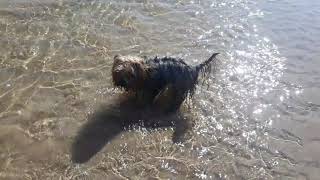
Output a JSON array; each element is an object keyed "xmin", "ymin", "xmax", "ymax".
[{"xmin": 71, "ymin": 95, "xmax": 191, "ymax": 163}]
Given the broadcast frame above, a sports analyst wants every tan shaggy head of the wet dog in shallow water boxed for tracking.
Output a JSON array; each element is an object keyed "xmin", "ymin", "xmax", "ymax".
[{"xmin": 112, "ymin": 55, "xmax": 147, "ymax": 91}]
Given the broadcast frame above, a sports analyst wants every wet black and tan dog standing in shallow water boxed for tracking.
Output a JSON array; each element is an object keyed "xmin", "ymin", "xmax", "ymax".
[{"xmin": 112, "ymin": 53, "xmax": 219, "ymax": 112}]
